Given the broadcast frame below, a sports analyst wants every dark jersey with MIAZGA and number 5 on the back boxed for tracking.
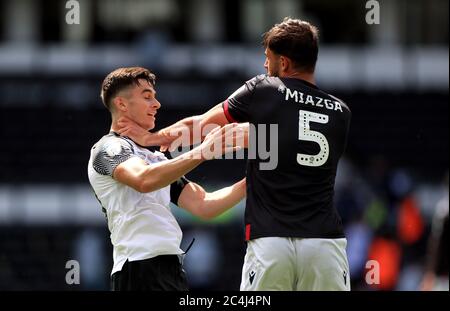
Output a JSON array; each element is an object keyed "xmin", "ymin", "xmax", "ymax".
[{"xmin": 223, "ymin": 75, "xmax": 351, "ymax": 240}]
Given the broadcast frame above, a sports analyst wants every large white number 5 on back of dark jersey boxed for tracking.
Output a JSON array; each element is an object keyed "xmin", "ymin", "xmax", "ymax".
[{"xmin": 297, "ymin": 110, "xmax": 330, "ymax": 167}]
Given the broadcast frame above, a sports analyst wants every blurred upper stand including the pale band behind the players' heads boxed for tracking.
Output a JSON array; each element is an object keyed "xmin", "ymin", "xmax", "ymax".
[{"xmin": 0, "ymin": 0, "xmax": 448, "ymax": 89}]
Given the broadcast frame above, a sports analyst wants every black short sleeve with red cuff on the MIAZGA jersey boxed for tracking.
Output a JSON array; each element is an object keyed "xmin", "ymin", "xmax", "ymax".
[{"xmin": 223, "ymin": 75, "xmax": 265, "ymax": 122}]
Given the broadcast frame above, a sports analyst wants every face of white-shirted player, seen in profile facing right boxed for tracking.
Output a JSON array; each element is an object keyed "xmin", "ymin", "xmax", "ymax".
[{"xmin": 128, "ymin": 79, "xmax": 161, "ymax": 130}]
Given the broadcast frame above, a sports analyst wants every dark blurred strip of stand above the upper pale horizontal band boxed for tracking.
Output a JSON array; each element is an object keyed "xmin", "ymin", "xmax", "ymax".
[{"xmin": 0, "ymin": 0, "xmax": 448, "ymax": 46}]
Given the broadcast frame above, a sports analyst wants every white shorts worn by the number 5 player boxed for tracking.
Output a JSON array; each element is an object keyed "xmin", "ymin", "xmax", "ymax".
[{"xmin": 241, "ymin": 237, "xmax": 350, "ymax": 291}]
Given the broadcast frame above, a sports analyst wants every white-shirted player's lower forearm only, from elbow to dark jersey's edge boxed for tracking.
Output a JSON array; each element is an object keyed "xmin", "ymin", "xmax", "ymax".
[{"xmin": 201, "ymin": 179, "xmax": 247, "ymax": 219}]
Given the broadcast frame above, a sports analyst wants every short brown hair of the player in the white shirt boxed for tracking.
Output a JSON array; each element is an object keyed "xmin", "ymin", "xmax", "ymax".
[{"xmin": 100, "ymin": 67, "xmax": 156, "ymax": 111}]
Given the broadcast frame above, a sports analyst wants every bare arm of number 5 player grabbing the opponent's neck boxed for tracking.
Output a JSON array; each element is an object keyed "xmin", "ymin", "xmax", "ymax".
[{"xmin": 118, "ymin": 103, "xmax": 229, "ymax": 151}]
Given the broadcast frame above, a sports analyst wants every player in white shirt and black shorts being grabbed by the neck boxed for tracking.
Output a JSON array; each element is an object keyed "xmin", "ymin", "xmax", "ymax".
[{"xmin": 88, "ymin": 67, "xmax": 246, "ymax": 290}]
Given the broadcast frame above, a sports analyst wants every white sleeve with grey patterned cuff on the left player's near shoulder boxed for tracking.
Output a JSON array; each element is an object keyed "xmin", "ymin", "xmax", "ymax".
[{"xmin": 92, "ymin": 139, "xmax": 135, "ymax": 177}]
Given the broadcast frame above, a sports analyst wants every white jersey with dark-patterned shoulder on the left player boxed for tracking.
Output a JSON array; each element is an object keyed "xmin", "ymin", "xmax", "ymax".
[{"xmin": 88, "ymin": 133, "xmax": 183, "ymax": 274}]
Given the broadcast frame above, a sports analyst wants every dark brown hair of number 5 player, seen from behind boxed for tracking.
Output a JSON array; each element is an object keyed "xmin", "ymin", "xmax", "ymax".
[{"xmin": 263, "ymin": 17, "xmax": 319, "ymax": 72}]
